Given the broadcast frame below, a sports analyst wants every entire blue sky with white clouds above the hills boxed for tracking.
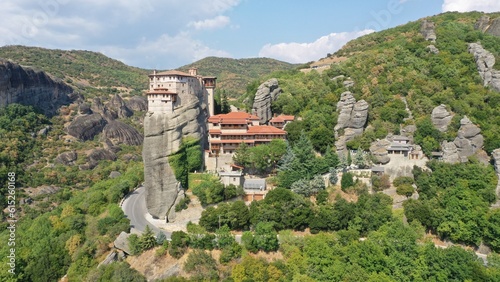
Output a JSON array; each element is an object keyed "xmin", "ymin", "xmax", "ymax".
[{"xmin": 0, "ymin": 0, "xmax": 500, "ymax": 70}]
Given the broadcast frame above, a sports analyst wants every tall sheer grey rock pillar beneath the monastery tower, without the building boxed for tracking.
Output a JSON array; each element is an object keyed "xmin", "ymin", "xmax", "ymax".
[{"xmin": 142, "ymin": 98, "xmax": 207, "ymax": 222}]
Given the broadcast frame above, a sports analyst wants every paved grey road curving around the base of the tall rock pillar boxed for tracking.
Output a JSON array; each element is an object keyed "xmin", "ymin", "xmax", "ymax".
[{"xmin": 122, "ymin": 186, "xmax": 172, "ymax": 239}]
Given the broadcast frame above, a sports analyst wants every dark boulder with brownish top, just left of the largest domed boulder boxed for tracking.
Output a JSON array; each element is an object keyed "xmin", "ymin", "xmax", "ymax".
[{"xmin": 66, "ymin": 113, "xmax": 107, "ymax": 141}]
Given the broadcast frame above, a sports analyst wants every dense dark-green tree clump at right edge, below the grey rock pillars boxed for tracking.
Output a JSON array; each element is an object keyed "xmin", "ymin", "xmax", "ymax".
[{"xmin": 403, "ymin": 161, "xmax": 499, "ymax": 247}]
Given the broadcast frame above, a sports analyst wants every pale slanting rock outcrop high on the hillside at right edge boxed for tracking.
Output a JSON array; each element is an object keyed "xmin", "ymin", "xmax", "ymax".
[{"xmin": 469, "ymin": 43, "xmax": 500, "ymax": 92}]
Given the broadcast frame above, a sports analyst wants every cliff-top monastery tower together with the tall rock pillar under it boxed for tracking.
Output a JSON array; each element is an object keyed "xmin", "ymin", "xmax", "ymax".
[{"xmin": 142, "ymin": 68, "xmax": 216, "ymax": 222}]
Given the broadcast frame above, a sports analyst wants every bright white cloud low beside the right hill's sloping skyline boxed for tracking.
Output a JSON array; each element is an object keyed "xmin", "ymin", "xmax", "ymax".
[{"xmin": 259, "ymin": 29, "xmax": 373, "ymax": 63}]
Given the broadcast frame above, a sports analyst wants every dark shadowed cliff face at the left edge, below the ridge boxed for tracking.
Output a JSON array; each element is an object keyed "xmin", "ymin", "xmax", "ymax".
[{"xmin": 0, "ymin": 59, "xmax": 73, "ymax": 116}]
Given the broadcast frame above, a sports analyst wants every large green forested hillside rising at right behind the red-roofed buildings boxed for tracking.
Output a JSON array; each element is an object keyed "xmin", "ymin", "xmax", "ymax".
[{"xmin": 244, "ymin": 12, "xmax": 500, "ymax": 153}]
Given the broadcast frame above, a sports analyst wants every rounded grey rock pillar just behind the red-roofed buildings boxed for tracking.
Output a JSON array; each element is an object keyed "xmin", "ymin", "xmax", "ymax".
[{"xmin": 252, "ymin": 78, "xmax": 282, "ymax": 123}]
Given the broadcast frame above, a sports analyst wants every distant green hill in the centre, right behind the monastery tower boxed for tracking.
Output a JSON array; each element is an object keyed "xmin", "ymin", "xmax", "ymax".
[{"xmin": 179, "ymin": 57, "xmax": 297, "ymax": 97}]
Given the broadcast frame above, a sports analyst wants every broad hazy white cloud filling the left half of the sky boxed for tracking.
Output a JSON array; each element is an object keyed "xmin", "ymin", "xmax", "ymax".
[{"xmin": 0, "ymin": 0, "xmax": 240, "ymax": 68}]
